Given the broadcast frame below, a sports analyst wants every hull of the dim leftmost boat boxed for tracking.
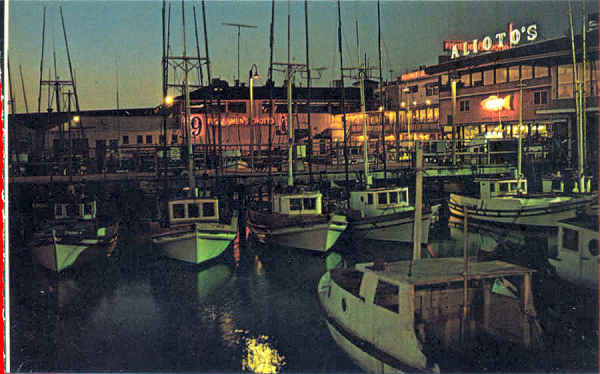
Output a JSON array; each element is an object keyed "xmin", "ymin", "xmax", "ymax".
[{"xmin": 32, "ymin": 224, "xmax": 118, "ymax": 272}]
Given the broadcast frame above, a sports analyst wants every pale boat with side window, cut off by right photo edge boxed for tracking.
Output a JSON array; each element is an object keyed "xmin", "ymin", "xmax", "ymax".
[{"xmin": 549, "ymin": 215, "xmax": 599, "ymax": 289}]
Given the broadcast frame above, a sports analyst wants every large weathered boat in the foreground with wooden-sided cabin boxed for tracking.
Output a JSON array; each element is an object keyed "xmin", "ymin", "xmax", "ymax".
[{"xmin": 318, "ymin": 258, "xmax": 542, "ymax": 373}]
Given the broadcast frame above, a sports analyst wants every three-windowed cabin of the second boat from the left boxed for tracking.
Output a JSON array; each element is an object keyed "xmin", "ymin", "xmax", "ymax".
[{"xmin": 169, "ymin": 197, "xmax": 219, "ymax": 224}]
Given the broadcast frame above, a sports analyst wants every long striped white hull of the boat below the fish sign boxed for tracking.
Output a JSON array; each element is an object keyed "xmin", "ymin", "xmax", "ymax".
[{"xmin": 448, "ymin": 194, "xmax": 597, "ymax": 228}]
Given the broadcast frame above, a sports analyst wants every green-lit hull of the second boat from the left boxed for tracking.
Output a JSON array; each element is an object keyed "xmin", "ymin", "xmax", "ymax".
[{"xmin": 152, "ymin": 215, "xmax": 237, "ymax": 264}]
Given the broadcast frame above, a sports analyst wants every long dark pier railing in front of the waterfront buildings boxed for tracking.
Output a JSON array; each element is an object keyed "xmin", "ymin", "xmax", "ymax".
[{"xmin": 9, "ymin": 140, "xmax": 551, "ymax": 176}]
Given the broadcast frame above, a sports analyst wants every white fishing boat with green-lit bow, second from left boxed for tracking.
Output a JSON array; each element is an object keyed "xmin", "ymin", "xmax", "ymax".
[{"xmin": 152, "ymin": 197, "xmax": 238, "ymax": 264}]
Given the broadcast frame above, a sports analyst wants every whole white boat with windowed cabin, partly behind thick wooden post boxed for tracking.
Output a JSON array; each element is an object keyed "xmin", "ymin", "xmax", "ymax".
[{"xmin": 347, "ymin": 187, "xmax": 440, "ymax": 244}]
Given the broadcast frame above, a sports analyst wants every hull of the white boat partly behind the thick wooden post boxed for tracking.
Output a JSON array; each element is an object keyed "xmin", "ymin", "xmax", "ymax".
[{"xmin": 349, "ymin": 205, "xmax": 437, "ymax": 244}]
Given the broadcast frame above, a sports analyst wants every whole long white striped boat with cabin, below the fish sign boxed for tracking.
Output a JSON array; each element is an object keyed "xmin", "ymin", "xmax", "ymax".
[{"xmin": 448, "ymin": 178, "xmax": 598, "ymax": 229}]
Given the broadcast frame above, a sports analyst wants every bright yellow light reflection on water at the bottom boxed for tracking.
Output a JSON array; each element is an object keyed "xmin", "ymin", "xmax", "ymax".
[{"xmin": 242, "ymin": 335, "xmax": 285, "ymax": 373}]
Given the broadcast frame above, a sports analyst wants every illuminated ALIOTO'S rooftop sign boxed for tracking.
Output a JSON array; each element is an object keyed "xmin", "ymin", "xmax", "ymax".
[{"xmin": 442, "ymin": 22, "xmax": 538, "ymax": 59}]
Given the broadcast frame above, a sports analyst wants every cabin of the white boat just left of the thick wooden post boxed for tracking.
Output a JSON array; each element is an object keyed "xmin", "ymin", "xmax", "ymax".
[{"xmin": 350, "ymin": 187, "xmax": 410, "ymax": 217}]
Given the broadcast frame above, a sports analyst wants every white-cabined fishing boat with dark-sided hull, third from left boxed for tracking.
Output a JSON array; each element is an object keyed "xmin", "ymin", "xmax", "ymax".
[{"xmin": 248, "ymin": 191, "xmax": 348, "ymax": 252}]
